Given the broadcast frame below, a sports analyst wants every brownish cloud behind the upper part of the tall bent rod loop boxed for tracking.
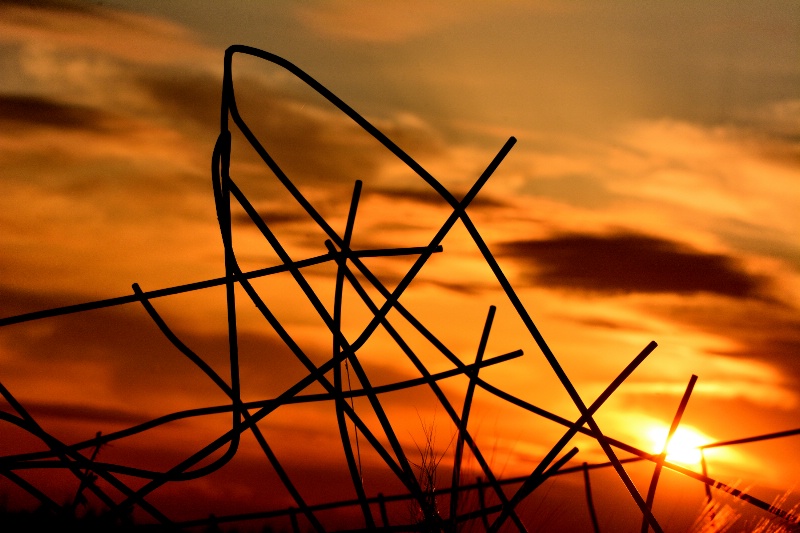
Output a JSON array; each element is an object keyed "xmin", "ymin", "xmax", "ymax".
[{"xmin": 140, "ymin": 68, "xmax": 388, "ymax": 187}]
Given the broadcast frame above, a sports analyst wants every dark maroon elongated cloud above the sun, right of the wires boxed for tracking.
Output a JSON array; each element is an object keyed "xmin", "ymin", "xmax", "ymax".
[{"xmin": 500, "ymin": 233, "xmax": 765, "ymax": 298}]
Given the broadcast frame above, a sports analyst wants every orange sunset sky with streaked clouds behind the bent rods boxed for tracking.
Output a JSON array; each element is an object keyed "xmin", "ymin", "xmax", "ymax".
[{"xmin": 0, "ymin": 0, "xmax": 800, "ymax": 527}]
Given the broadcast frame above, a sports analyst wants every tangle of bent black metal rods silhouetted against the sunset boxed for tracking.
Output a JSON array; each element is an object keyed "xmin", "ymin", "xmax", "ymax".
[{"xmin": 0, "ymin": 45, "xmax": 800, "ymax": 532}]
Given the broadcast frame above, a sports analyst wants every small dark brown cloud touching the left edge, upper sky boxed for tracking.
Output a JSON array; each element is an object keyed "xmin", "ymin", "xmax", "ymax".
[{"xmin": 0, "ymin": 95, "xmax": 108, "ymax": 132}]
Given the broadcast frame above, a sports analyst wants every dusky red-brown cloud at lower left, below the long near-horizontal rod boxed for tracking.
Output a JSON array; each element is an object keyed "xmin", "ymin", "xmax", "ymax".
[{"xmin": 0, "ymin": 278, "xmax": 356, "ymax": 416}]
